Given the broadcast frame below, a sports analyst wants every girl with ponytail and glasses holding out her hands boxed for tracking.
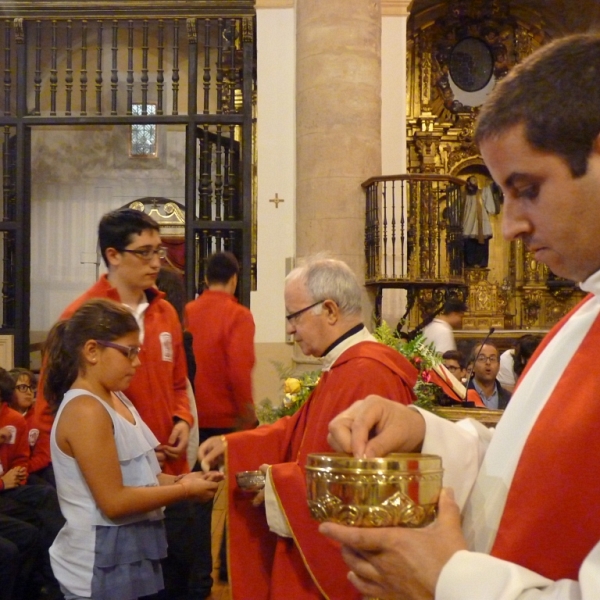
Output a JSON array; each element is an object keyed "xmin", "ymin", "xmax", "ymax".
[{"xmin": 44, "ymin": 298, "xmax": 222, "ymax": 600}]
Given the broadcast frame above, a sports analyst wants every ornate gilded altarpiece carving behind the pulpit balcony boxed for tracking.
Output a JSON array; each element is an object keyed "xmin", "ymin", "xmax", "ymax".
[{"xmin": 407, "ymin": 0, "xmax": 581, "ymax": 329}]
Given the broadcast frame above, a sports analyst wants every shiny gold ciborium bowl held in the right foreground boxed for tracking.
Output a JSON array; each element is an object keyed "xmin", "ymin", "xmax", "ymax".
[{"xmin": 306, "ymin": 453, "xmax": 443, "ymax": 527}]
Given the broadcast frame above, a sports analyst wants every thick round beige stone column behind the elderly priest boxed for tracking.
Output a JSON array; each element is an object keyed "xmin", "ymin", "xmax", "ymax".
[{"xmin": 296, "ymin": 0, "xmax": 381, "ymax": 296}]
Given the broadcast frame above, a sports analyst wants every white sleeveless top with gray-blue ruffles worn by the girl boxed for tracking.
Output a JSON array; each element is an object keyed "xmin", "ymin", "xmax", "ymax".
[{"xmin": 50, "ymin": 389, "xmax": 167, "ymax": 600}]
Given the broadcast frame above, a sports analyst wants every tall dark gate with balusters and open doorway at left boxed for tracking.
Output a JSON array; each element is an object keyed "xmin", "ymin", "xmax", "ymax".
[{"xmin": 0, "ymin": 0, "xmax": 256, "ymax": 365}]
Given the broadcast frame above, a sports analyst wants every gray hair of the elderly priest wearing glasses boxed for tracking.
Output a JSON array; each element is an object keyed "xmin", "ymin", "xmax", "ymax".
[{"xmin": 285, "ymin": 255, "xmax": 362, "ymax": 315}]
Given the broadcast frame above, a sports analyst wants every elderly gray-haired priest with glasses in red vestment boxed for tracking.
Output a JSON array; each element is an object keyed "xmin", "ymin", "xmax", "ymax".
[{"xmin": 198, "ymin": 259, "xmax": 417, "ymax": 600}]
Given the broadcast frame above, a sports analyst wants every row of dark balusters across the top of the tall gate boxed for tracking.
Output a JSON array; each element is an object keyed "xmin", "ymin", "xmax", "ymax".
[{"xmin": 1, "ymin": 18, "xmax": 243, "ymax": 117}]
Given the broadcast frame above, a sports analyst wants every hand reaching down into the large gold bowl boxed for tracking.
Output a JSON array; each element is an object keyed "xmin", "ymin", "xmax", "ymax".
[{"xmin": 327, "ymin": 395, "xmax": 425, "ymax": 458}]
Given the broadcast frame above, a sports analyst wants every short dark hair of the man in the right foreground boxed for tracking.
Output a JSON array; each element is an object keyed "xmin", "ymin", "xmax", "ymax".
[{"xmin": 475, "ymin": 34, "xmax": 600, "ymax": 177}]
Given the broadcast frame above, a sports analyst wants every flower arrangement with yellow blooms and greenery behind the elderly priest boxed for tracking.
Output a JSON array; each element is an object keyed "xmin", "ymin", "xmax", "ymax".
[{"xmin": 256, "ymin": 321, "xmax": 442, "ymax": 425}]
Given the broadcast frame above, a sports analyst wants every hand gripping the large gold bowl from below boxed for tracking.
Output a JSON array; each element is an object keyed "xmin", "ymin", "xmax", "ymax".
[{"xmin": 319, "ymin": 488, "xmax": 467, "ymax": 600}]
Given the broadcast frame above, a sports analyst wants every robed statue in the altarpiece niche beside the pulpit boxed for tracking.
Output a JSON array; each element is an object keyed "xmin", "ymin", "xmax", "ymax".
[{"xmin": 462, "ymin": 175, "xmax": 500, "ymax": 269}]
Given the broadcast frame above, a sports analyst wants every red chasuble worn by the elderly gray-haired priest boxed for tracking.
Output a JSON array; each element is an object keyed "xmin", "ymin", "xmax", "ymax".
[{"xmin": 227, "ymin": 342, "xmax": 417, "ymax": 600}]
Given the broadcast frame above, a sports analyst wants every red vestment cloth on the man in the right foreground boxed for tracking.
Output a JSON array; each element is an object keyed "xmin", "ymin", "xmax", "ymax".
[{"xmin": 491, "ymin": 297, "xmax": 600, "ymax": 581}]
